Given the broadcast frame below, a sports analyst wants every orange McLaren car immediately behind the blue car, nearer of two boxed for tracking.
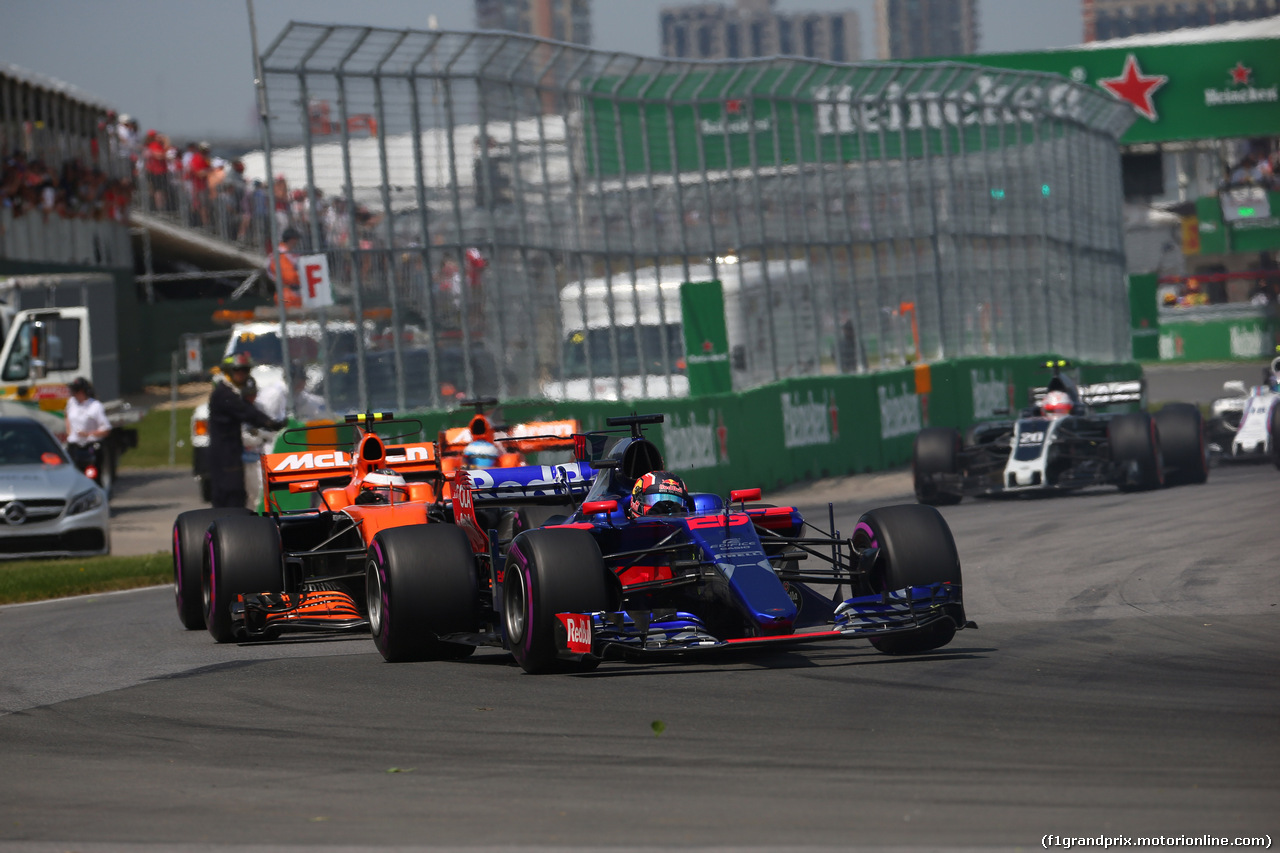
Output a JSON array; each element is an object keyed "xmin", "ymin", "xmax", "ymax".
[{"xmin": 173, "ymin": 412, "xmax": 452, "ymax": 643}]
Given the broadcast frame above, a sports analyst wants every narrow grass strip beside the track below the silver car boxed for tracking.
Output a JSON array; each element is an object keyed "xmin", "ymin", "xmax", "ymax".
[{"xmin": 0, "ymin": 551, "xmax": 173, "ymax": 605}]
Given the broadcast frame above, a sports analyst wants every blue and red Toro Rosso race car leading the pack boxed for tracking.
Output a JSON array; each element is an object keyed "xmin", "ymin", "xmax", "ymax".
[{"xmin": 367, "ymin": 415, "xmax": 975, "ymax": 672}]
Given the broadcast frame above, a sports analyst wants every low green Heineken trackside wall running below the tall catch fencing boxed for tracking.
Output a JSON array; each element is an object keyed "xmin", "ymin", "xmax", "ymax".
[{"xmin": 267, "ymin": 353, "xmax": 1142, "ymax": 507}]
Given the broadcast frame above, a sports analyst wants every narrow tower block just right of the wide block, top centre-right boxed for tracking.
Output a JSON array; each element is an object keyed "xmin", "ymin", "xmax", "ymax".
[{"xmin": 876, "ymin": 0, "xmax": 978, "ymax": 59}]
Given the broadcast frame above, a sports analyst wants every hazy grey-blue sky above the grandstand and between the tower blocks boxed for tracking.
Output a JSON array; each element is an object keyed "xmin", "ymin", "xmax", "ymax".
[{"xmin": 0, "ymin": 0, "xmax": 1083, "ymax": 142}]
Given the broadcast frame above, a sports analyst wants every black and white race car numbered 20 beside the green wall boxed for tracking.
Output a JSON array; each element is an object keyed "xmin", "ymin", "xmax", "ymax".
[{"xmin": 911, "ymin": 360, "xmax": 1208, "ymax": 506}]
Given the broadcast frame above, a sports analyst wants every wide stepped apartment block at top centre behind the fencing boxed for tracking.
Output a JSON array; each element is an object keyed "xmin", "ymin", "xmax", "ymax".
[{"xmin": 660, "ymin": 0, "xmax": 861, "ymax": 63}]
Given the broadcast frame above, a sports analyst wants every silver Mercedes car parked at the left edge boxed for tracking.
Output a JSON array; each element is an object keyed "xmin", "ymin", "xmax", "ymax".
[{"xmin": 0, "ymin": 416, "xmax": 111, "ymax": 558}]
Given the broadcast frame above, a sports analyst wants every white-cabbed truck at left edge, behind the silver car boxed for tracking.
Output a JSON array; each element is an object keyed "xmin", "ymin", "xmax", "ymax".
[{"xmin": 0, "ymin": 274, "xmax": 143, "ymax": 494}]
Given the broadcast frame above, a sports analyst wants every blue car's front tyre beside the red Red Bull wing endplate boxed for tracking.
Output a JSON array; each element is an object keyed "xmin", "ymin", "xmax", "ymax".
[{"xmin": 502, "ymin": 529, "xmax": 613, "ymax": 674}]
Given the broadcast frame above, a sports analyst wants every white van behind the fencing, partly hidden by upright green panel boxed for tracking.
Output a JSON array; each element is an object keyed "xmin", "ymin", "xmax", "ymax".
[{"xmin": 541, "ymin": 256, "xmax": 817, "ymax": 400}]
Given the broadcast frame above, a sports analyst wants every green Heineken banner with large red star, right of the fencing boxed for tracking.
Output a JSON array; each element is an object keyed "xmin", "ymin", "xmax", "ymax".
[{"xmin": 966, "ymin": 38, "xmax": 1280, "ymax": 145}]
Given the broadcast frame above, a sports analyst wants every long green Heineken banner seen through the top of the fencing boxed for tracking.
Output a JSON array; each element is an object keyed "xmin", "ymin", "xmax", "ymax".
[{"xmin": 584, "ymin": 61, "xmax": 1132, "ymax": 177}]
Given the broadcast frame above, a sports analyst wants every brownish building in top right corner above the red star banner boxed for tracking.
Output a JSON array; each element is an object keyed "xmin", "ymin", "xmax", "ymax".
[{"xmin": 1084, "ymin": 0, "xmax": 1280, "ymax": 41}]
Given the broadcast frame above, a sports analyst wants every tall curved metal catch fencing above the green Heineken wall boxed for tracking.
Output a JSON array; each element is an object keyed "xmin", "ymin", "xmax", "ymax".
[{"xmin": 254, "ymin": 23, "xmax": 1133, "ymax": 409}]
